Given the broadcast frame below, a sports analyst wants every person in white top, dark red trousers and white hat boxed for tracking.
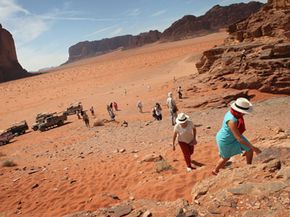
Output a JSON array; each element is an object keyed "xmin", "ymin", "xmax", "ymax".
[{"xmin": 172, "ymin": 113, "xmax": 197, "ymax": 172}]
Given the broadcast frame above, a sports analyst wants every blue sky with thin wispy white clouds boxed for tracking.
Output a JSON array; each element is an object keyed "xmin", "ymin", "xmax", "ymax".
[{"xmin": 0, "ymin": 0, "xmax": 266, "ymax": 71}]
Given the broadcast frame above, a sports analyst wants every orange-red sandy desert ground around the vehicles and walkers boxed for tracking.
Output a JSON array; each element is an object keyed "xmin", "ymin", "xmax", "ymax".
[{"xmin": 0, "ymin": 33, "xmax": 289, "ymax": 216}]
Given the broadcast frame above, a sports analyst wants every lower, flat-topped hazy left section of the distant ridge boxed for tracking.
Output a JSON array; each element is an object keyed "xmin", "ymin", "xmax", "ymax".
[{"xmin": 68, "ymin": 30, "xmax": 161, "ymax": 62}]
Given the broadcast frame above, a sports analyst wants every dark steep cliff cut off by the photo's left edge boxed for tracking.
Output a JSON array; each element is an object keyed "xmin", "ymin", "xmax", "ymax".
[{"xmin": 0, "ymin": 24, "xmax": 30, "ymax": 82}]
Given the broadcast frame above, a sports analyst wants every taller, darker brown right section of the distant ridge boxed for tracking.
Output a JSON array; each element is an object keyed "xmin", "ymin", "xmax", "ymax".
[{"xmin": 161, "ymin": 2, "xmax": 263, "ymax": 41}]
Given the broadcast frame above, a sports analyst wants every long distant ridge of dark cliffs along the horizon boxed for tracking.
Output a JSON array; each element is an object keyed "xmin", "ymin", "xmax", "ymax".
[{"xmin": 67, "ymin": 2, "xmax": 263, "ymax": 63}]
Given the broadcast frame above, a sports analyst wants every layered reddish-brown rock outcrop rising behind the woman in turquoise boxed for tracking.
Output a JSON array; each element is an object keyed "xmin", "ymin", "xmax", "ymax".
[{"xmin": 196, "ymin": 0, "xmax": 290, "ymax": 94}]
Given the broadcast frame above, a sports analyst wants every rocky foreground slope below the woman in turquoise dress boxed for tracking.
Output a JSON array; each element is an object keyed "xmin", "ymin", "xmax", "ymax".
[{"xmin": 65, "ymin": 133, "xmax": 290, "ymax": 217}]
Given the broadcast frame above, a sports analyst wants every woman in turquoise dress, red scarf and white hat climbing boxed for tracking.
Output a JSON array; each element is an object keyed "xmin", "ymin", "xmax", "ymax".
[{"xmin": 212, "ymin": 98, "xmax": 261, "ymax": 175}]
